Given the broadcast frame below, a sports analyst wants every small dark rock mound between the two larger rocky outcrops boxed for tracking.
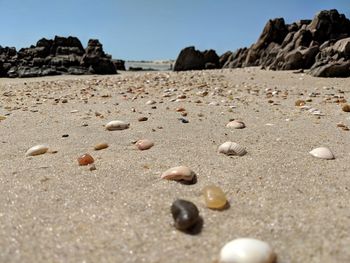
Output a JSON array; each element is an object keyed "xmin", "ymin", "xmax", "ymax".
[{"xmin": 174, "ymin": 46, "xmax": 220, "ymax": 71}]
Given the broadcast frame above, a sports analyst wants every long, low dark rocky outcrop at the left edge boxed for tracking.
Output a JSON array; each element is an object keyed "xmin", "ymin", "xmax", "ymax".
[{"xmin": 0, "ymin": 36, "xmax": 116, "ymax": 78}]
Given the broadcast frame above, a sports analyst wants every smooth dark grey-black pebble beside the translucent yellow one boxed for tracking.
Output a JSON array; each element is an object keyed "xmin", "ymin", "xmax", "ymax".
[{"xmin": 171, "ymin": 199, "xmax": 200, "ymax": 231}]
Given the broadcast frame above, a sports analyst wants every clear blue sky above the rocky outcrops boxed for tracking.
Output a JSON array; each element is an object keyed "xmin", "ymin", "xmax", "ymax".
[{"xmin": 0, "ymin": 0, "xmax": 350, "ymax": 60}]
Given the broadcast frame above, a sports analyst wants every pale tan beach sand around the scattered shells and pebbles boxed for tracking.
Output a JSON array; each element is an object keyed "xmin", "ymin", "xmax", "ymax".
[{"xmin": 0, "ymin": 68, "xmax": 350, "ymax": 263}]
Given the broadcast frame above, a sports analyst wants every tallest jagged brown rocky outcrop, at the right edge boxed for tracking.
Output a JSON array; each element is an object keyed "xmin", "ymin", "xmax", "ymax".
[{"xmin": 220, "ymin": 10, "xmax": 350, "ymax": 77}]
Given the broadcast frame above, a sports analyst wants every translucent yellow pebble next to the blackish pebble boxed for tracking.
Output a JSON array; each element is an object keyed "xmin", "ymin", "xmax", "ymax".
[{"xmin": 202, "ymin": 185, "xmax": 227, "ymax": 209}]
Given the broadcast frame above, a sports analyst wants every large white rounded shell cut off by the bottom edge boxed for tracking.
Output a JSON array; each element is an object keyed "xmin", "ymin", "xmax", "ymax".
[{"xmin": 220, "ymin": 238, "xmax": 276, "ymax": 263}]
